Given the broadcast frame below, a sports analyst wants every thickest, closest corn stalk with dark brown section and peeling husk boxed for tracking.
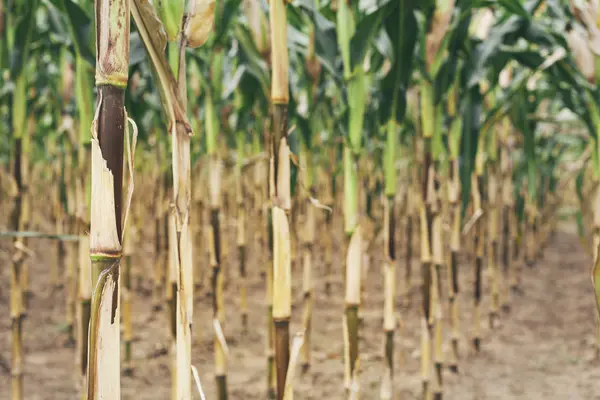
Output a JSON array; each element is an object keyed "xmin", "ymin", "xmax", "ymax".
[{"xmin": 87, "ymin": 0, "xmax": 131, "ymax": 400}]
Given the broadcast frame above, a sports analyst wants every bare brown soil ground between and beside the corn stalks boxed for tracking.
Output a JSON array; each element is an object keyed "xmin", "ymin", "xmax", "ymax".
[{"xmin": 0, "ymin": 220, "xmax": 600, "ymax": 400}]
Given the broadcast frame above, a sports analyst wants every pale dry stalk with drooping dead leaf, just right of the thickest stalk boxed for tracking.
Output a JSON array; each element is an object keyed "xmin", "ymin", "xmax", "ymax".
[{"xmin": 132, "ymin": 0, "xmax": 203, "ymax": 400}]
